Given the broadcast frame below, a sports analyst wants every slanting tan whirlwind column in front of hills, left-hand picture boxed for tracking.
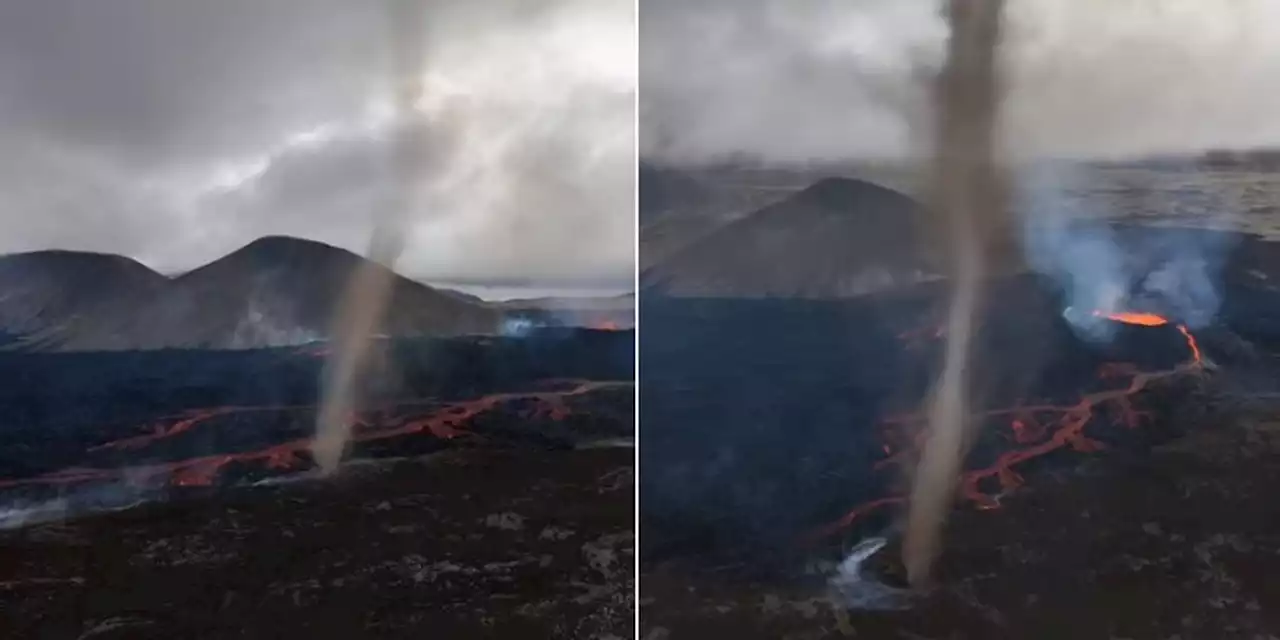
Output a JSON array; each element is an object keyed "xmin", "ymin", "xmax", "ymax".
[{"xmin": 312, "ymin": 0, "xmax": 429, "ymax": 475}]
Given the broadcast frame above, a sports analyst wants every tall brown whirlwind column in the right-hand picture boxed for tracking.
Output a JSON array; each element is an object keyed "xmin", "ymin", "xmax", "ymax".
[{"xmin": 902, "ymin": 0, "xmax": 1007, "ymax": 586}]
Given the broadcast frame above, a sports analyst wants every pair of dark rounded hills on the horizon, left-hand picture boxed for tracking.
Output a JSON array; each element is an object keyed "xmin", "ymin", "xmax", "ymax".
[{"xmin": 0, "ymin": 237, "xmax": 502, "ymax": 351}]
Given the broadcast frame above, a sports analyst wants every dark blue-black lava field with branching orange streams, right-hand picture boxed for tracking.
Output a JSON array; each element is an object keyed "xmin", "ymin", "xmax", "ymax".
[{"xmin": 640, "ymin": 288, "xmax": 1212, "ymax": 563}]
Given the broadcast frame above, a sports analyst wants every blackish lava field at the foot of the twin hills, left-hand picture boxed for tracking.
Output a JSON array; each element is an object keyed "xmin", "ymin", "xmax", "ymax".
[{"xmin": 0, "ymin": 330, "xmax": 635, "ymax": 488}]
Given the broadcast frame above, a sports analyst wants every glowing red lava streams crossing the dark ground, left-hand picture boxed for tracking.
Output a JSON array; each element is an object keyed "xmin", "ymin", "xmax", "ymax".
[{"xmin": 0, "ymin": 380, "xmax": 631, "ymax": 489}]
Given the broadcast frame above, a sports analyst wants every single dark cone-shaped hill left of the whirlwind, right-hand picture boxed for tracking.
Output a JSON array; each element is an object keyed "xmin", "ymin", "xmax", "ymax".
[{"xmin": 640, "ymin": 178, "xmax": 936, "ymax": 298}]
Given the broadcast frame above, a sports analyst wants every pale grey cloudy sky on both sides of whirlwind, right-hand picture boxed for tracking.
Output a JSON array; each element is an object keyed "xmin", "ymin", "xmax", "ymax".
[{"xmin": 640, "ymin": 0, "xmax": 1280, "ymax": 161}]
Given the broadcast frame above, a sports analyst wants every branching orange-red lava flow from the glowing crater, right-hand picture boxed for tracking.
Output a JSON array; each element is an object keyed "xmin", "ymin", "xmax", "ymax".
[{"xmin": 806, "ymin": 312, "xmax": 1204, "ymax": 541}]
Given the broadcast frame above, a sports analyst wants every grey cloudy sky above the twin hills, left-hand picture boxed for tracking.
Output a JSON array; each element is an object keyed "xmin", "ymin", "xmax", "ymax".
[{"xmin": 0, "ymin": 0, "xmax": 636, "ymax": 282}]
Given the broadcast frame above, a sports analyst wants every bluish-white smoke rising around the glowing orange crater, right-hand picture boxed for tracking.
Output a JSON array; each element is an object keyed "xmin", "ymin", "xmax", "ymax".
[{"xmin": 1016, "ymin": 163, "xmax": 1239, "ymax": 340}]
